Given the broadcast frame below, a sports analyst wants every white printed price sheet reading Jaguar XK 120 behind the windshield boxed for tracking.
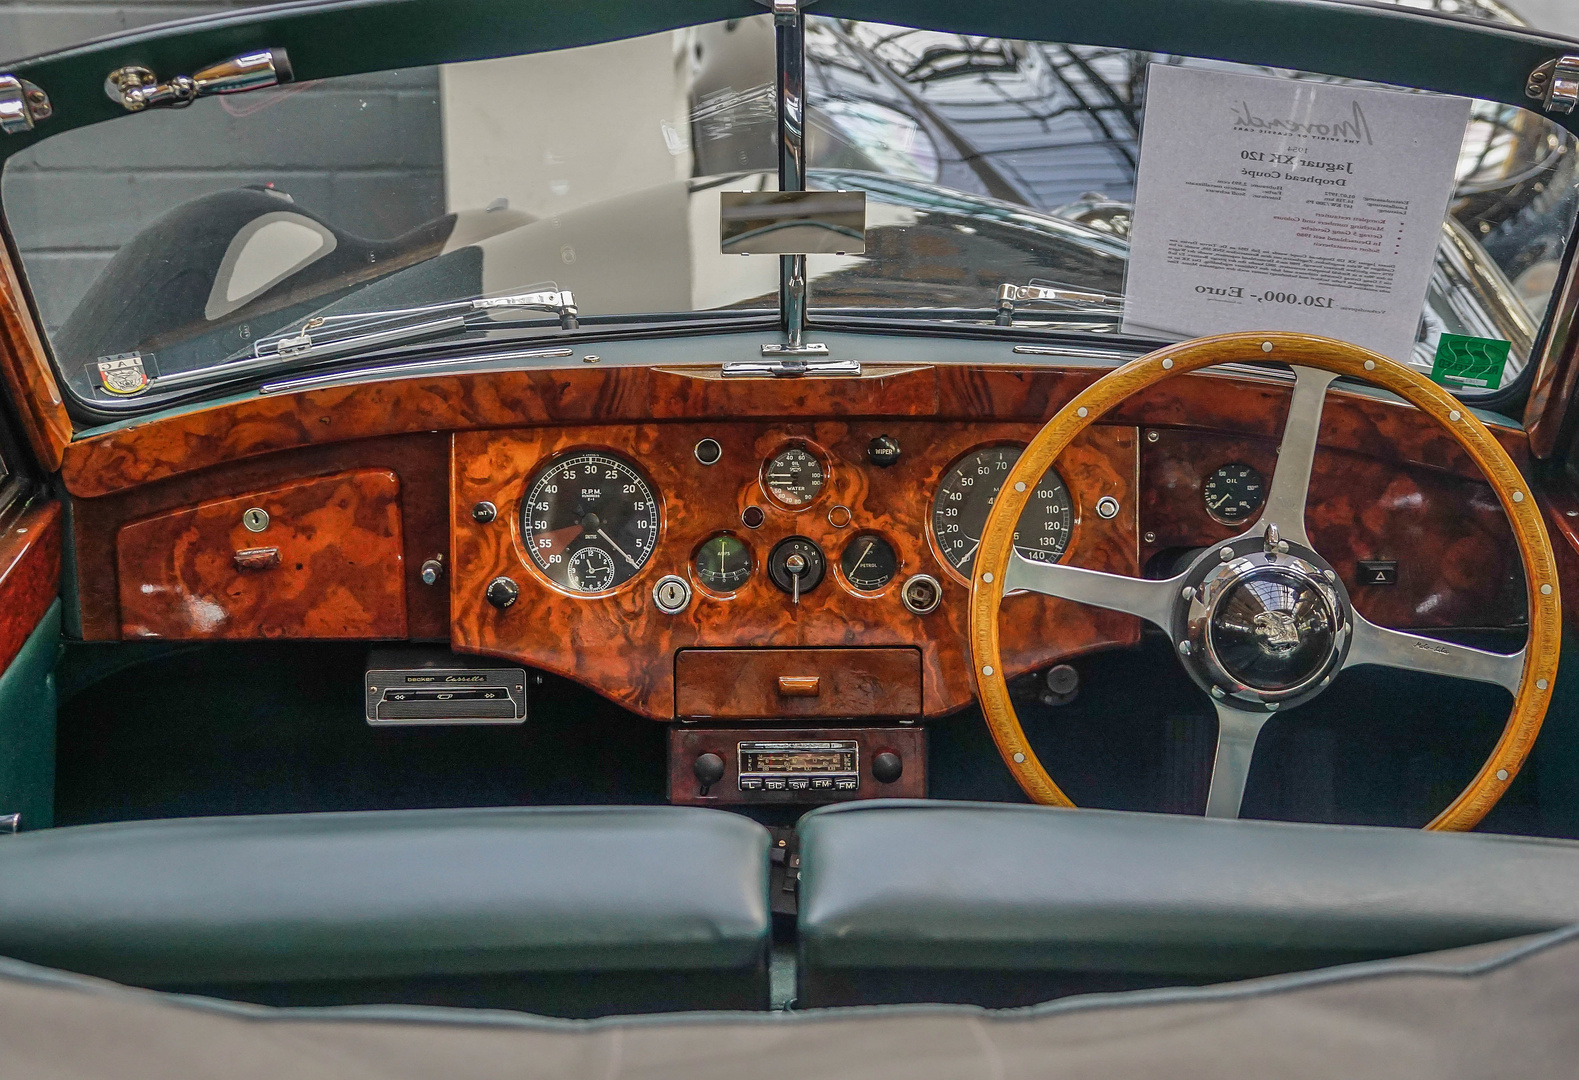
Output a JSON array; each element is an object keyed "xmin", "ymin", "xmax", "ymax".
[{"xmin": 1124, "ymin": 63, "xmax": 1470, "ymax": 363}]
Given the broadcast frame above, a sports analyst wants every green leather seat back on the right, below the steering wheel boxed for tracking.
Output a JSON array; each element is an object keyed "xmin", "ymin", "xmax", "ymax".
[{"xmin": 799, "ymin": 802, "xmax": 1579, "ymax": 1006}]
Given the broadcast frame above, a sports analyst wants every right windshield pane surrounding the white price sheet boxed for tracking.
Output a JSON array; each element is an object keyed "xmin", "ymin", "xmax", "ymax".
[{"xmin": 807, "ymin": 19, "xmax": 1579, "ymax": 392}]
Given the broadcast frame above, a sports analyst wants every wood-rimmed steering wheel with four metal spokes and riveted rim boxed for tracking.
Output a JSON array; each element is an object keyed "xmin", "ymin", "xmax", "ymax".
[{"xmin": 970, "ymin": 333, "xmax": 1562, "ymax": 829}]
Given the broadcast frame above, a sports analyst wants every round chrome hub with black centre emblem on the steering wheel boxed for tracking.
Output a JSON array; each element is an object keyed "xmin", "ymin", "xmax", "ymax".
[{"xmin": 1173, "ymin": 534, "xmax": 1353, "ymax": 712}]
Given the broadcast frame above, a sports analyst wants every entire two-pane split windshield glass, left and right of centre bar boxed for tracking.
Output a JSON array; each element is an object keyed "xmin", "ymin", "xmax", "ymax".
[{"xmin": 0, "ymin": 7, "xmax": 1579, "ymax": 407}]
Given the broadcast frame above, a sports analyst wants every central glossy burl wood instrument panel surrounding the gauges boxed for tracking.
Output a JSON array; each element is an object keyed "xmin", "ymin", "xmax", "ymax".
[{"xmin": 450, "ymin": 420, "xmax": 1140, "ymax": 720}]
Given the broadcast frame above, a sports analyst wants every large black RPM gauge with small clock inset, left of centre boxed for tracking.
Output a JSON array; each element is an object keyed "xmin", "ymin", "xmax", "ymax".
[{"xmin": 521, "ymin": 450, "xmax": 660, "ymax": 594}]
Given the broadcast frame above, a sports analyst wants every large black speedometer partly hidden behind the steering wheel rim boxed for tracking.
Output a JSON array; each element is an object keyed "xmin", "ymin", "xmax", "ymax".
[{"xmin": 932, "ymin": 447, "xmax": 1074, "ymax": 576}]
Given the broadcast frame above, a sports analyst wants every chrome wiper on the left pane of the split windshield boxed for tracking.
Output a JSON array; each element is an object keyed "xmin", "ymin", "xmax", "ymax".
[{"xmin": 253, "ymin": 289, "xmax": 579, "ymax": 360}]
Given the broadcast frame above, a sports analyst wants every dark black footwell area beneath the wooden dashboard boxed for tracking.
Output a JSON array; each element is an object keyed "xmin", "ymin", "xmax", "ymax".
[{"xmin": 55, "ymin": 641, "xmax": 1579, "ymax": 835}]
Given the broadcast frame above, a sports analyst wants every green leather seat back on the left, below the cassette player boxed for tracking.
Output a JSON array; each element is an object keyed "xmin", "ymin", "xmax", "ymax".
[{"xmin": 0, "ymin": 807, "xmax": 771, "ymax": 1017}]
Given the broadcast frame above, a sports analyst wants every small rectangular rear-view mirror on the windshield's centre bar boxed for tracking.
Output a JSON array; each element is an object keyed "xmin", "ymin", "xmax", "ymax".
[{"xmin": 718, "ymin": 191, "xmax": 867, "ymax": 254}]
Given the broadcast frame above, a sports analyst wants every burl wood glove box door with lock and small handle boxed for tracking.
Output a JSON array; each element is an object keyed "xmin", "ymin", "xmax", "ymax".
[{"xmin": 115, "ymin": 469, "xmax": 406, "ymax": 638}]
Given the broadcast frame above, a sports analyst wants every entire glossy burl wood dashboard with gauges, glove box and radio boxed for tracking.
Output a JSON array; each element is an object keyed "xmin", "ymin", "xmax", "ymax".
[{"xmin": 63, "ymin": 335, "xmax": 1528, "ymax": 801}]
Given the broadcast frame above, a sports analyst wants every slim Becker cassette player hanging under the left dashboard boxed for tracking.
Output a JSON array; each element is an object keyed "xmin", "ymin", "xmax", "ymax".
[{"xmin": 363, "ymin": 668, "xmax": 526, "ymax": 726}]
